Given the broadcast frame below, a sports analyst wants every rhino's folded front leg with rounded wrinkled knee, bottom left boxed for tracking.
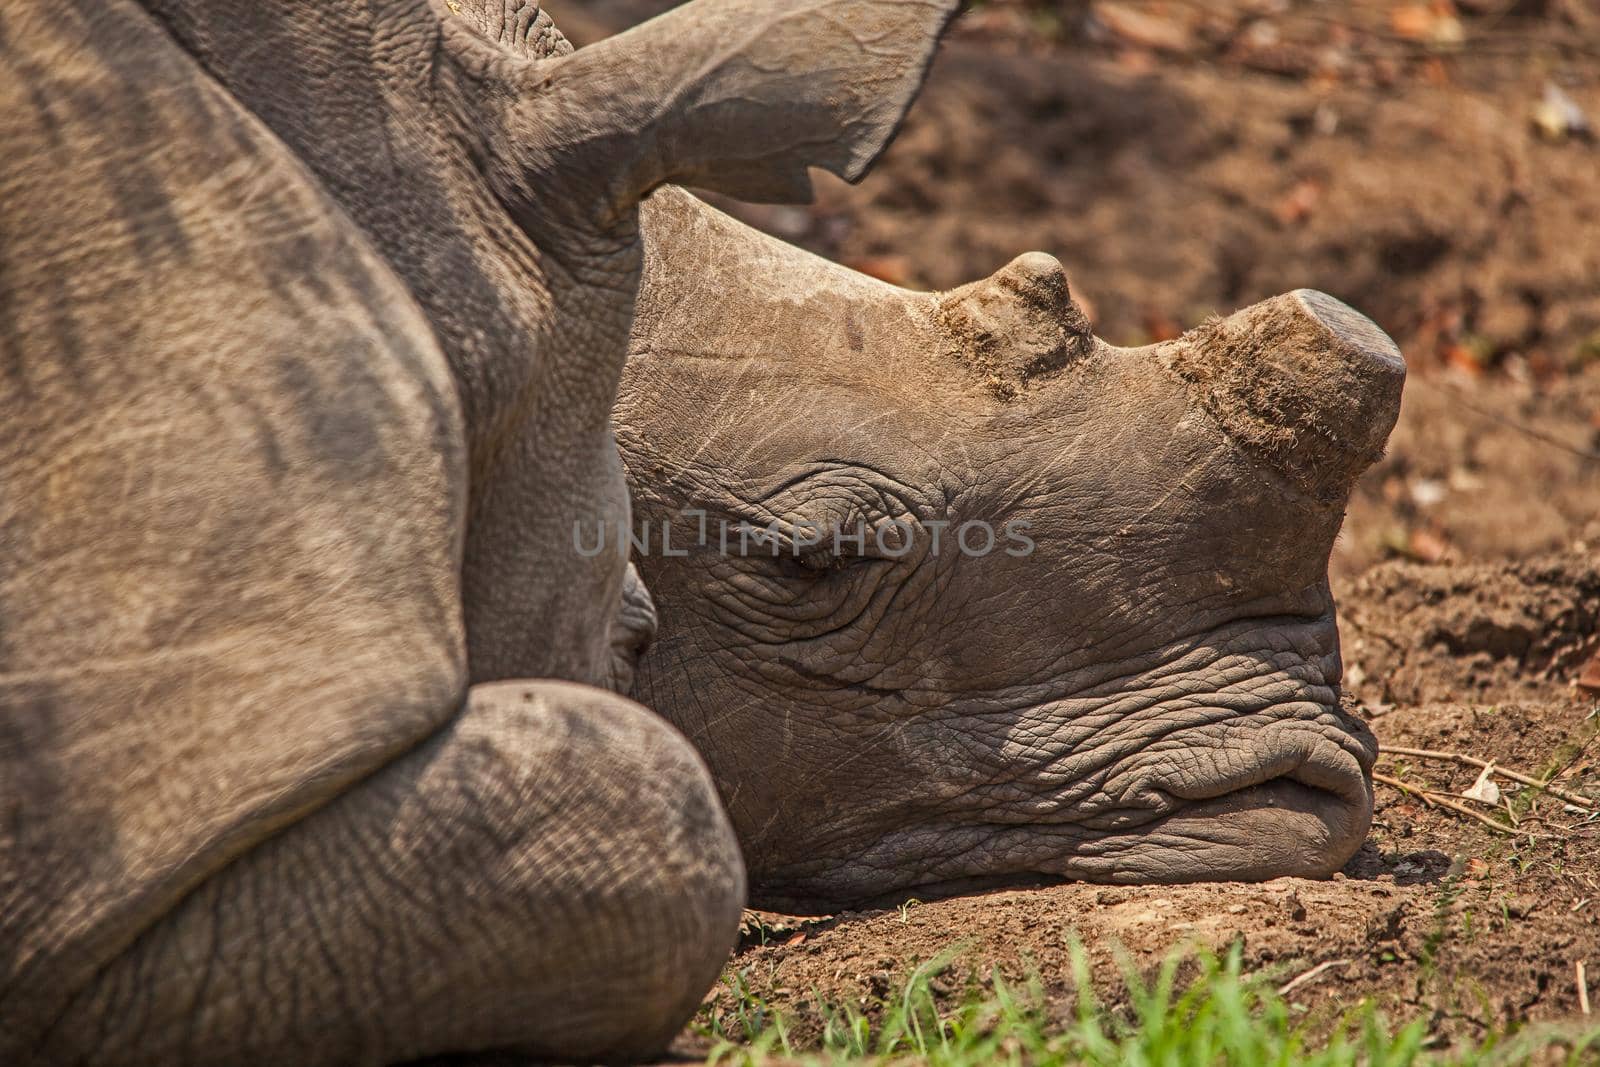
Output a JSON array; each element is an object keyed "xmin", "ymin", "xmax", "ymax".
[{"xmin": 42, "ymin": 681, "xmax": 744, "ymax": 1064}]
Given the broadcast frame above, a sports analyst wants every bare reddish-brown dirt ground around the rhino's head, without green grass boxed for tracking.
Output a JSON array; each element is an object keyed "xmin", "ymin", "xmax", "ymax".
[{"xmin": 549, "ymin": 0, "xmax": 1600, "ymax": 1040}]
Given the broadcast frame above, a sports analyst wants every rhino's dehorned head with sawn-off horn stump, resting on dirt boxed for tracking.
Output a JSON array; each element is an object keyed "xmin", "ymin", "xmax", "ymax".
[{"xmin": 616, "ymin": 190, "xmax": 1405, "ymax": 909}]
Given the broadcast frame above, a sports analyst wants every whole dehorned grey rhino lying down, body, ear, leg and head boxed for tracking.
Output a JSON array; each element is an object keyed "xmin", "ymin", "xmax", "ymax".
[{"xmin": 0, "ymin": 0, "xmax": 1403, "ymax": 1064}]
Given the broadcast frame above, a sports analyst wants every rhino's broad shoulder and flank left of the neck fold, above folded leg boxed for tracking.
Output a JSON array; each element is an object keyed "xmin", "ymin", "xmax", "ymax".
[{"xmin": 0, "ymin": 0, "xmax": 466, "ymax": 1051}]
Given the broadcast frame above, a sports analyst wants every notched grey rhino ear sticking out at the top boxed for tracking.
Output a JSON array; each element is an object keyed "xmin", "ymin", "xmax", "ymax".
[{"xmin": 470, "ymin": 0, "xmax": 958, "ymax": 218}]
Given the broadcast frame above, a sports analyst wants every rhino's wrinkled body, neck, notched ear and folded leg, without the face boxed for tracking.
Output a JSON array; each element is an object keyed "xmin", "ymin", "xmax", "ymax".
[{"xmin": 0, "ymin": 0, "xmax": 954, "ymax": 1064}]
